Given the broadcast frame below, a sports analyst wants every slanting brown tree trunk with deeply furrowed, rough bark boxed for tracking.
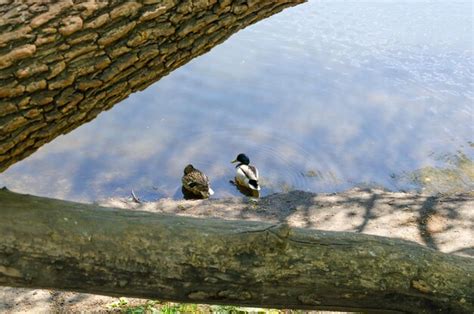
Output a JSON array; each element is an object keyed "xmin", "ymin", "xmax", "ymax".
[{"xmin": 0, "ymin": 0, "xmax": 304, "ymax": 172}]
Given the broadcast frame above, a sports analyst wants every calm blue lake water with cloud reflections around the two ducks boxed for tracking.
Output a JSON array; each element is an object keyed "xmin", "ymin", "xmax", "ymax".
[{"xmin": 0, "ymin": 0, "xmax": 474, "ymax": 202}]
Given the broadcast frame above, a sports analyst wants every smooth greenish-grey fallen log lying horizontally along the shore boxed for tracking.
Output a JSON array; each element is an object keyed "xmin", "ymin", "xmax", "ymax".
[{"xmin": 0, "ymin": 190, "xmax": 474, "ymax": 313}]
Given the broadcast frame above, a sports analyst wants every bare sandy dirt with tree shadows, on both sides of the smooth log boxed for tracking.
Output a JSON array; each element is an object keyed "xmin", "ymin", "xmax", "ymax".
[{"xmin": 0, "ymin": 189, "xmax": 474, "ymax": 313}]
